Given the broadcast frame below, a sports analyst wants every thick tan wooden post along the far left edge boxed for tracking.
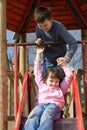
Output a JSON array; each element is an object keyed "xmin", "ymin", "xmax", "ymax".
[{"xmin": 0, "ymin": 0, "xmax": 8, "ymax": 130}]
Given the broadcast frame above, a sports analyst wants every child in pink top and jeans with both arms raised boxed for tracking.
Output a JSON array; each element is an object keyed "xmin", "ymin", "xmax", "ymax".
[{"xmin": 23, "ymin": 48, "xmax": 72, "ymax": 130}]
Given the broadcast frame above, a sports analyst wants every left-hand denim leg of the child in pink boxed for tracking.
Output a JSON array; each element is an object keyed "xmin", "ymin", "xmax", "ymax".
[{"xmin": 22, "ymin": 105, "xmax": 44, "ymax": 130}]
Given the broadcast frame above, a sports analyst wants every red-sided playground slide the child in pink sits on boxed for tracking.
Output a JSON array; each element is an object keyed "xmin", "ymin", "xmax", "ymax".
[{"xmin": 14, "ymin": 71, "xmax": 85, "ymax": 130}]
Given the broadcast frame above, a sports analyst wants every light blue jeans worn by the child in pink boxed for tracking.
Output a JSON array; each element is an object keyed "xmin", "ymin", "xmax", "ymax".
[{"xmin": 22, "ymin": 103, "xmax": 60, "ymax": 130}]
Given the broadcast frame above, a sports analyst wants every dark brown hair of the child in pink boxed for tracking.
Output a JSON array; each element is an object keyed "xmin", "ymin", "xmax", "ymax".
[{"xmin": 44, "ymin": 67, "xmax": 65, "ymax": 83}]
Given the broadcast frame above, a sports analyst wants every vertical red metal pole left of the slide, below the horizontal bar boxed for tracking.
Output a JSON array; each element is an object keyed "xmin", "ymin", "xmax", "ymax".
[{"xmin": 14, "ymin": 44, "xmax": 18, "ymax": 119}]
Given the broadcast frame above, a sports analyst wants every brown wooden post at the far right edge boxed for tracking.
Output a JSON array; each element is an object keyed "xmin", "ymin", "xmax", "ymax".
[{"xmin": 82, "ymin": 29, "xmax": 87, "ymax": 118}]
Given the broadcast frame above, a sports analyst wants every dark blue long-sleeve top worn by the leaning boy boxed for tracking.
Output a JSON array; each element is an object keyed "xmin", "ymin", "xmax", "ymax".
[{"xmin": 36, "ymin": 20, "xmax": 78, "ymax": 62}]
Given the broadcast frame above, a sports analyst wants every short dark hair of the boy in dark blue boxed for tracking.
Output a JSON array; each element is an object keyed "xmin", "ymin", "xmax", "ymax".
[{"xmin": 34, "ymin": 6, "xmax": 52, "ymax": 23}]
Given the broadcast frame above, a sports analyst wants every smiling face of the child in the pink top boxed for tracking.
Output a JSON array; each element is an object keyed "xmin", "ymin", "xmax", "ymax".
[{"xmin": 46, "ymin": 76, "xmax": 59, "ymax": 87}]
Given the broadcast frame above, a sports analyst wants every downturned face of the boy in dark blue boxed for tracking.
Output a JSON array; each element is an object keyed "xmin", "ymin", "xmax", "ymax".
[{"xmin": 38, "ymin": 19, "xmax": 52, "ymax": 32}]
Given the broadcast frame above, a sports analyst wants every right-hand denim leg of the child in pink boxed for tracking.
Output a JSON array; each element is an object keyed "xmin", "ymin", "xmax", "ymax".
[{"xmin": 37, "ymin": 103, "xmax": 60, "ymax": 130}]
